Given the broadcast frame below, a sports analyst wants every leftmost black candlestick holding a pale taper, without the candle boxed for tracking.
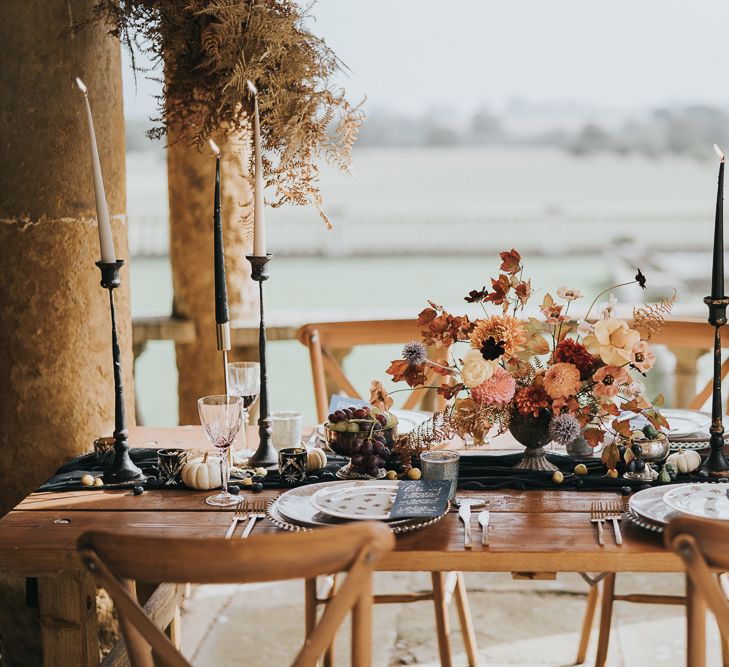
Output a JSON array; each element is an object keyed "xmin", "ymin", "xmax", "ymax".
[{"xmin": 96, "ymin": 259, "xmax": 145, "ymax": 484}]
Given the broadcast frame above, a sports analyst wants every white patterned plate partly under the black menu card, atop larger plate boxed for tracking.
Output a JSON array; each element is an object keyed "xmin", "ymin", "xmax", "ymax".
[{"xmin": 311, "ymin": 480, "xmax": 398, "ymax": 521}]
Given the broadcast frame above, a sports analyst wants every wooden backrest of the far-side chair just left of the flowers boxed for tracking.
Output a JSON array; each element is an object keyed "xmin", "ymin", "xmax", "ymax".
[{"xmin": 297, "ymin": 319, "xmax": 448, "ymax": 421}]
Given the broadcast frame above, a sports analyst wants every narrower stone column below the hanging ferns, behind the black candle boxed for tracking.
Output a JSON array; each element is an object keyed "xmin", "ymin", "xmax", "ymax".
[{"xmin": 167, "ymin": 128, "xmax": 257, "ymax": 424}]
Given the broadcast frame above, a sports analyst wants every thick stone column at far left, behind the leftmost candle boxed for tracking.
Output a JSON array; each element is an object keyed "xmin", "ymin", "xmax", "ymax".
[{"xmin": 0, "ymin": 0, "xmax": 134, "ymax": 513}]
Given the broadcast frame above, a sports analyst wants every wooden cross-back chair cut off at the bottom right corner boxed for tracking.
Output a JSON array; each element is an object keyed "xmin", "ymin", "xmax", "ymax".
[{"xmin": 664, "ymin": 516, "xmax": 729, "ymax": 667}]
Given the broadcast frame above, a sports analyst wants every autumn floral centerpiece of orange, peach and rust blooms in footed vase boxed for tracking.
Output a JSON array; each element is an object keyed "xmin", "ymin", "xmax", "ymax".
[{"xmin": 371, "ymin": 250, "xmax": 673, "ymax": 470}]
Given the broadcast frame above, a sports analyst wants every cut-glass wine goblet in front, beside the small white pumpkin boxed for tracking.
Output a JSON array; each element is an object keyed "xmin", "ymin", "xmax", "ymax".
[{"xmin": 197, "ymin": 394, "xmax": 243, "ymax": 507}]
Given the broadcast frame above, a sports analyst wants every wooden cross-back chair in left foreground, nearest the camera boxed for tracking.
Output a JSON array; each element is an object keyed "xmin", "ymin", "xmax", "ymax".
[{"xmin": 78, "ymin": 522, "xmax": 395, "ymax": 667}]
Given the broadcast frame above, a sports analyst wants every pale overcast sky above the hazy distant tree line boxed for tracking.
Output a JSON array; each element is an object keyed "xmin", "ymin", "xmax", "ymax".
[{"xmin": 124, "ymin": 0, "xmax": 729, "ymax": 118}]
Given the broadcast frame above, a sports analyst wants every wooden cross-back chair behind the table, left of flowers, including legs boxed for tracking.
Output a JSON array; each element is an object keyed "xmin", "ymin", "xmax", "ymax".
[{"xmin": 297, "ymin": 319, "xmax": 478, "ymax": 667}]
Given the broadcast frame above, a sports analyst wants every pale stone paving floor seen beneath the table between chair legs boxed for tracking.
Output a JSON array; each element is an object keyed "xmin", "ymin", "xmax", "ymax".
[{"xmin": 182, "ymin": 573, "xmax": 721, "ymax": 667}]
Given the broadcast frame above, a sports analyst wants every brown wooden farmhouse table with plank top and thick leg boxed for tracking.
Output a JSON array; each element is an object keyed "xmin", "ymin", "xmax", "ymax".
[{"xmin": 0, "ymin": 426, "xmax": 683, "ymax": 667}]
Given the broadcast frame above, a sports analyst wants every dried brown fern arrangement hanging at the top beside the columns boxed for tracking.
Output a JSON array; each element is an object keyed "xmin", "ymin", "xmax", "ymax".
[{"xmin": 94, "ymin": 0, "xmax": 364, "ymax": 227}]
